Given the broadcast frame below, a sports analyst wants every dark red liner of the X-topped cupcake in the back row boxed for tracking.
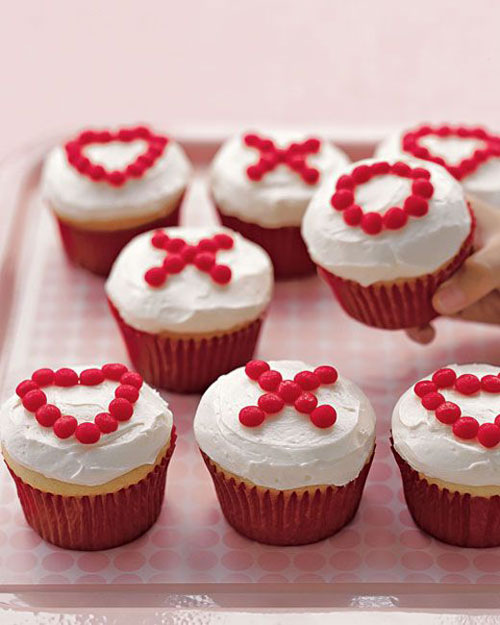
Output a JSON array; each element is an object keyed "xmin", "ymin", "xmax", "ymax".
[{"xmin": 217, "ymin": 208, "xmax": 315, "ymax": 280}]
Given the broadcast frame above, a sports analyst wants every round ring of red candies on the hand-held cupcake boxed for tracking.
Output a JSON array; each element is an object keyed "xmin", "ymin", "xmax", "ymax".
[{"xmin": 330, "ymin": 161, "xmax": 434, "ymax": 236}]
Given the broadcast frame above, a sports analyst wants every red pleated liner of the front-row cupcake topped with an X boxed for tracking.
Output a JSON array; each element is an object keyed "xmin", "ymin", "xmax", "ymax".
[{"xmin": 201, "ymin": 452, "xmax": 373, "ymax": 545}]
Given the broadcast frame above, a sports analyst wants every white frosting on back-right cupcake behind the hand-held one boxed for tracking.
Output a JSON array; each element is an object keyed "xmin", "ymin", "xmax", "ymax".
[{"xmin": 376, "ymin": 131, "xmax": 500, "ymax": 208}]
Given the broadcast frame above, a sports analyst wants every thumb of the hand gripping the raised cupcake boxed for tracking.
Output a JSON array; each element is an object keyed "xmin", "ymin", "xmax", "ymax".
[{"xmin": 432, "ymin": 241, "xmax": 500, "ymax": 315}]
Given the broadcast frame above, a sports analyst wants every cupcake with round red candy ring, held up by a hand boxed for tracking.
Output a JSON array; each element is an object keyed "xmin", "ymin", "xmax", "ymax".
[{"xmin": 302, "ymin": 159, "xmax": 474, "ymax": 329}]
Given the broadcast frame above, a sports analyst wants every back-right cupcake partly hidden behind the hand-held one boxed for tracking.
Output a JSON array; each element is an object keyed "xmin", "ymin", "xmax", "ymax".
[{"xmin": 376, "ymin": 124, "xmax": 500, "ymax": 208}]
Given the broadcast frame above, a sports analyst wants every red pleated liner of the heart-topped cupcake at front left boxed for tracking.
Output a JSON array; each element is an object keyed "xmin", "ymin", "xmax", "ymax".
[{"xmin": 7, "ymin": 427, "xmax": 176, "ymax": 551}]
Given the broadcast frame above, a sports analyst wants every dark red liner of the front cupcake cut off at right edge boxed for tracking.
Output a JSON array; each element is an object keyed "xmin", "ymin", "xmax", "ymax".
[{"xmin": 392, "ymin": 447, "xmax": 500, "ymax": 547}]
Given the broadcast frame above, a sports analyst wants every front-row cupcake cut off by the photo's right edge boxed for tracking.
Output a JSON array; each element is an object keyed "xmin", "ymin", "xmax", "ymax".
[{"xmin": 392, "ymin": 365, "xmax": 500, "ymax": 547}]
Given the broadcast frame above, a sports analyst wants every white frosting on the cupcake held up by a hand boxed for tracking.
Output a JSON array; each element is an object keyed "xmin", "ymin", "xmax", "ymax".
[{"xmin": 302, "ymin": 158, "xmax": 471, "ymax": 286}]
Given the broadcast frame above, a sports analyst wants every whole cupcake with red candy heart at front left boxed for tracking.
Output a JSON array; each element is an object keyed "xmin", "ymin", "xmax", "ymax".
[{"xmin": 0, "ymin": 364, "xmax": 176, "ymax": 551}]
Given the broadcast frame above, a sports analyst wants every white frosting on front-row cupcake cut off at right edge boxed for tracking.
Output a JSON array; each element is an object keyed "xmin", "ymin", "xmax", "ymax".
[{"xmin": 392, "ymin": 364, "xmax": 500, "ymax": 486}]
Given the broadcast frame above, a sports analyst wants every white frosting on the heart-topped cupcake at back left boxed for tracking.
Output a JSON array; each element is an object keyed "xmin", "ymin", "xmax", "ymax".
[{"xmin": 42, "ymin": 135, "xmax": 191, "ymax": 223}]
